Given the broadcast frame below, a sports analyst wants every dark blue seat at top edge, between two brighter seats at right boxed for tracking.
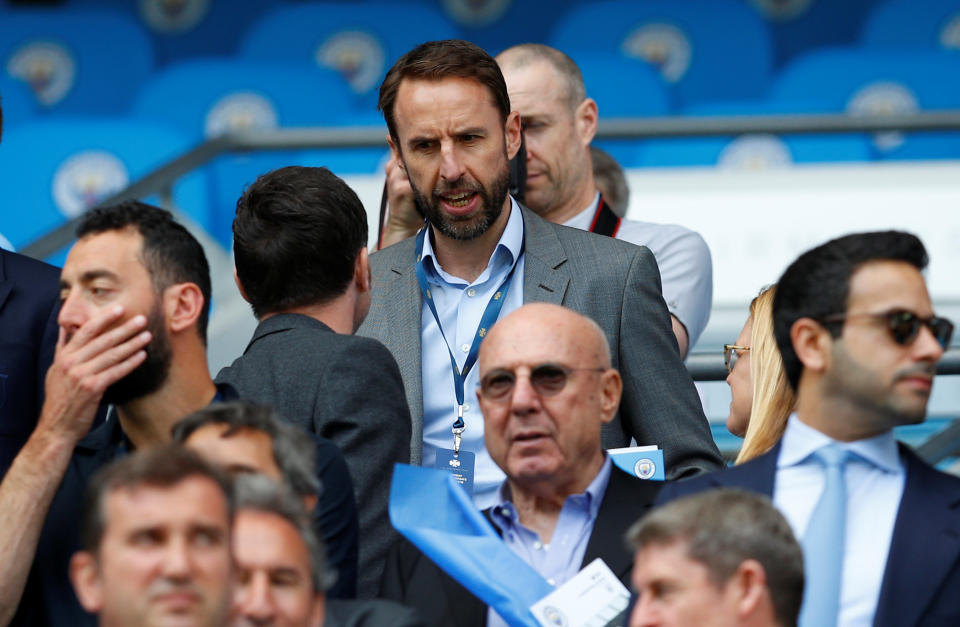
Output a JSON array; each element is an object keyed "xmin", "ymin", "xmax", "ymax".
[{"xmin": 750, "ymin": 0, "xmax": 878, "ymax": 67}]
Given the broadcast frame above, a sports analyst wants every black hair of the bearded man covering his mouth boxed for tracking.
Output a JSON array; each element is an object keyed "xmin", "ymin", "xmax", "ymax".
[{"xmin": 77, "ymin": 200, "xmax": 211, "ymax": 344}]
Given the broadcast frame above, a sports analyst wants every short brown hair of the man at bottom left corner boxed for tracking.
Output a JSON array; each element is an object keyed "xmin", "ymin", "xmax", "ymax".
[{"xmin": 80, "ymin": 444, "xmax": 234, "ymax": 553}]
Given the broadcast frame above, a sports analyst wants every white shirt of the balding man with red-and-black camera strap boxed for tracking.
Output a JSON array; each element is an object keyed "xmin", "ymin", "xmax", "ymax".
[{"xmin": 563, "ymin": 193, "xmax": 713, "ymax": 348}]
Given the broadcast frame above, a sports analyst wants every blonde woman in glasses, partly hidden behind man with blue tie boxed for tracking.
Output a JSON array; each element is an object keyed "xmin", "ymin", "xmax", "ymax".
[{"xmin": 723, "ymin": 285, "xmax": 795, "ymax": 464}]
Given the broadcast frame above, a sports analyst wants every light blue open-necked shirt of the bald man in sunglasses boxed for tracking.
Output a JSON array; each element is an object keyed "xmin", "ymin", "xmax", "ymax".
[{"xmin": 487, "ymin": 453, "xmax": 611, "ymax": 627}]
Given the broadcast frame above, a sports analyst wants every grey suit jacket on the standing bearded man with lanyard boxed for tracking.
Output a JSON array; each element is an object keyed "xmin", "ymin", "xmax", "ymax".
[{"xmin": 358, "ymin": 207, "xmax": 722, "ymax": 478}]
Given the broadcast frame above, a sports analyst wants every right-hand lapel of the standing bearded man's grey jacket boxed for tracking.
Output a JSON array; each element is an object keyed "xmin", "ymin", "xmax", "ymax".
[{"xmin": 520, "ymin": 207, "xmax": 570, "ymax": 305}]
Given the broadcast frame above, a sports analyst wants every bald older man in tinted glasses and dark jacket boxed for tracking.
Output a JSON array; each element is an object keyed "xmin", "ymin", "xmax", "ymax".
[{"xmin": 381, "ymin": 303, "xmax": 660, "ymax": 626}]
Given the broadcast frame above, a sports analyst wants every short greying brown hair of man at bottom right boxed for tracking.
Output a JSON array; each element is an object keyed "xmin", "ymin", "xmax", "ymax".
[{"xmin": 627, "ymin": 488, "xmax": 804, "ymax": 627}]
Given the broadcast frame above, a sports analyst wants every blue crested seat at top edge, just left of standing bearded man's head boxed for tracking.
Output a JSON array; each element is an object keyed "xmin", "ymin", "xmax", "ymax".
[{"xmin": 240, "ymin": 2, "xmax": 459, "ymax": 111}]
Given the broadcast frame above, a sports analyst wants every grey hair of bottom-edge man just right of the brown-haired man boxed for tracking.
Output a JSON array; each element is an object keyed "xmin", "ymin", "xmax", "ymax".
[{"xmin": 236, "ymin": 475, "xmax": 335, "ymax": 592}]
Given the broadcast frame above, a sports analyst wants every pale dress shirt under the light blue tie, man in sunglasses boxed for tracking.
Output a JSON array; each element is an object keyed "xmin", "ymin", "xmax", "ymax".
[{"xmin": 773, "ymin": 414, "xmax": 906, "ymax": 627}]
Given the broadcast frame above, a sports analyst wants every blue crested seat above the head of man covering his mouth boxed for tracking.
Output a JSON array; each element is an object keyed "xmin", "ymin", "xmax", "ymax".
[{"xmin": 0, "ymin": 116, "xmax": 209, "ymax": 260}]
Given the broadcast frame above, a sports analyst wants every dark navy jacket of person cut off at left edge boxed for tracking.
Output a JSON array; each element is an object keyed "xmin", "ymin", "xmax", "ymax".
[{"xmin": 0, "ymin": 249, "xmax": 60, "ymax": 477}]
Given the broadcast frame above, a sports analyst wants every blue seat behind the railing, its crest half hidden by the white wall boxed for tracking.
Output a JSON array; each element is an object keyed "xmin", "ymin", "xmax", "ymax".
[{"xmin": 636, "ymin": 102, "xmax": 872, "ymax": 170}]
